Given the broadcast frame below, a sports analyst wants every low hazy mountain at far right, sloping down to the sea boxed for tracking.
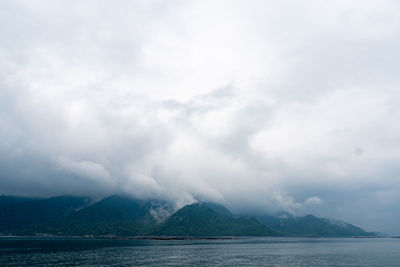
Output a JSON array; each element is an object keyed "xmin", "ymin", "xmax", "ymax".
[{"xmin": 256, "ymin": 214, "xmax": 376, "ymax": 237}]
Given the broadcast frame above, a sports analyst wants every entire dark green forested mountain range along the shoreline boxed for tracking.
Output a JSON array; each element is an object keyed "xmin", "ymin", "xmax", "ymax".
[{"xmin": 0, "ymin": 195, "xmax": 376, "ymax": 237}]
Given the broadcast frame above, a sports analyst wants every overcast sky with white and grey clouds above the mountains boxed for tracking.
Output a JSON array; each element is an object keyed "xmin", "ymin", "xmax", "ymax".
[{"xmin": 0, "ymin": 0, "xmax": 400, "ymax": 234}]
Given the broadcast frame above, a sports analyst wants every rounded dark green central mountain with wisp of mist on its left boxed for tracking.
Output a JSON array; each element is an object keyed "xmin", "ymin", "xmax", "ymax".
[{"xmin": 153, "ymin": 203, "xmax": 278, "ymax": 236}]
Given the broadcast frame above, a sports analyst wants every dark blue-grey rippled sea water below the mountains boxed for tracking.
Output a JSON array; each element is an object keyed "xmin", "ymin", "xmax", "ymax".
[{"xmin": 0, "ymin": 238, "xmax": 400, "ymax": 267}]
